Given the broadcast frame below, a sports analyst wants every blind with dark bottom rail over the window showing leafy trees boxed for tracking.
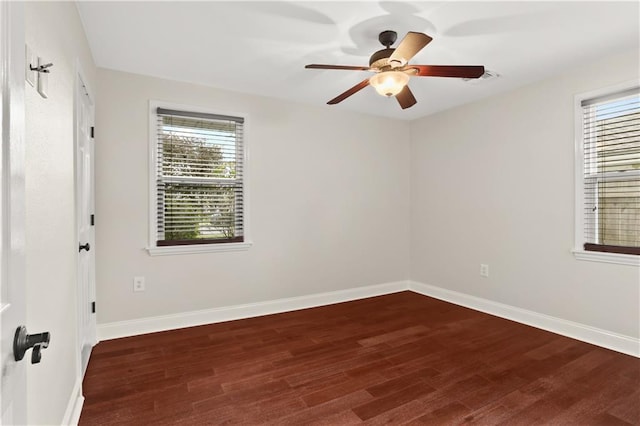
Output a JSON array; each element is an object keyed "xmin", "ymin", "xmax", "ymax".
[{"xmin": 156, "ymin": 108, "xmax": 244, "ymax": 246}]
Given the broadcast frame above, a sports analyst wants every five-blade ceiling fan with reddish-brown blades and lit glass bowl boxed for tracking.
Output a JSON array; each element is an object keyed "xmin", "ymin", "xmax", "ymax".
[{"xmin": 305, "ymin": 30, "xmax": 484, "ymax": 109}]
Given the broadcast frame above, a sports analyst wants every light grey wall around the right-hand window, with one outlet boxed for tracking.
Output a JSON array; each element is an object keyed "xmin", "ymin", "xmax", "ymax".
[{"xmin": 410, "ymin": 47, "xmax": 640, "ymax": 339}]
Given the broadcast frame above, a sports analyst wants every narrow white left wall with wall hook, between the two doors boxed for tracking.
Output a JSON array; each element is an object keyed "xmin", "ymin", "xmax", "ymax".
[{"xmin": 25, "ymin": 2, "xmax": 95, "ymax": 424}]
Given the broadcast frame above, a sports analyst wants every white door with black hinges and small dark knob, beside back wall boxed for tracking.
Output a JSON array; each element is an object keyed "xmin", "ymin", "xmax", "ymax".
[{"xmin": 76, "ymin": 74, "xmax": 96, "ymax": 375}]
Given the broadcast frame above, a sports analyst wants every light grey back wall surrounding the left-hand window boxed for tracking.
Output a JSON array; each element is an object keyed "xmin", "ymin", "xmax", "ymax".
[{"xmin": 96, "ymin": 70, "xmax": 409, "ymax": 324}]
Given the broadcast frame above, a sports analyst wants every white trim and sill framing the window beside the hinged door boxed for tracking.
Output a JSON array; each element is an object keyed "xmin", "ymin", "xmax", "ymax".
[{"xmin": 146, "ymin": 100, "xmax": 253, "ymax": 256}]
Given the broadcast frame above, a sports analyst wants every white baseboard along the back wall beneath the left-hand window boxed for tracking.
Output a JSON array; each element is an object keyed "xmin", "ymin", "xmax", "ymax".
[{"xmin": 98, "ymin": 281, "xmax": 409, "ymax": 340}]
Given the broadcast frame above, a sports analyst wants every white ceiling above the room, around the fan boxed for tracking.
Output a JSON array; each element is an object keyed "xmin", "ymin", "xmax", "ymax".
[{"xmin": 78, "ymin": 1, "xmax": 640, "ymax": 120}]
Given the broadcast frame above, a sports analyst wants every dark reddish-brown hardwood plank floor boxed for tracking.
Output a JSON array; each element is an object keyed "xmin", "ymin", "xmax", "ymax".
[{"xmin": 80, "ymin": 292, "xmax": 640, "ymax": 425}]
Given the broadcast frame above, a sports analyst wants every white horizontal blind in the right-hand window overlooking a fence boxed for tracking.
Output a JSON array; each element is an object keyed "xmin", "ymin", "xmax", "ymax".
[{"xmin": 582, "ymin": 88, "xmax": 640, "ymax": 255}]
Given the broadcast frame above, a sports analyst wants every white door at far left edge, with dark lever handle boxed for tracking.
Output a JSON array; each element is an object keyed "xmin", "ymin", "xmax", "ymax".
[{"xmin": 0, "ymin": 1, "xmax": 30, "ymax": 425}]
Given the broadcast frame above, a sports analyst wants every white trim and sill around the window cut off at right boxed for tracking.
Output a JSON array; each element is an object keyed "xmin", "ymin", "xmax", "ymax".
[{"xmin": 571, "ymin": 80, "xmax": 640, "ymax": 266}]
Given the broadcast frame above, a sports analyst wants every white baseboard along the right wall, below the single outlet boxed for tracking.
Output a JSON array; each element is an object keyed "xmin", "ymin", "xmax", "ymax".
[{"xmin": 409, "ymin": 281, "xmax": 640, "ymax": 358}]
